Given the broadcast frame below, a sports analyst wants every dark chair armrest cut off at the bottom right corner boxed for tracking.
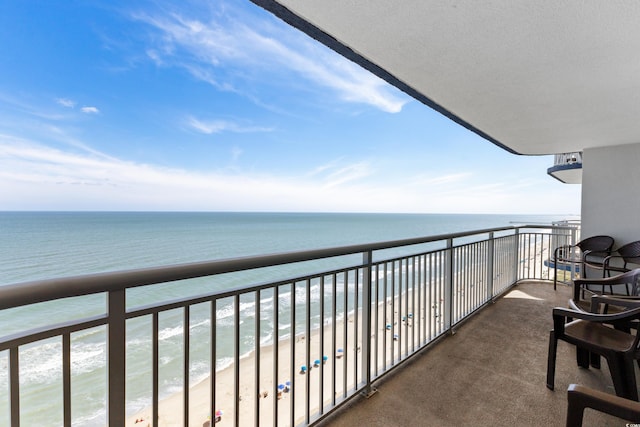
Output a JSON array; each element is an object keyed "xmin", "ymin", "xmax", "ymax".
[{"xmin": 567, "ymin": 384, "xmax": 640, "ymax": 427}]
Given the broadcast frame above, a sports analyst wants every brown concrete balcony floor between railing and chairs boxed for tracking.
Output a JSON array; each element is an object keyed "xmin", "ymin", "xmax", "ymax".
[{"xmin": 323, "ymin": 281, "xmax": 625, "ymax": 427}]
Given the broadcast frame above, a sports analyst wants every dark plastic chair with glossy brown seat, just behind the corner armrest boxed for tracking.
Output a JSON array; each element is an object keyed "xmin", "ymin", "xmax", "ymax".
[{"xmin": 547, "ymin": 295, "xmax": 640, "ymax": 401}]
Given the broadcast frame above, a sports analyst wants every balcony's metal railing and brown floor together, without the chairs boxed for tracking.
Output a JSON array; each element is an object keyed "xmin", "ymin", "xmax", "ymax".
[{"xmin": 5, "ymin": 225, "xmax": 624, "ymax": 427}]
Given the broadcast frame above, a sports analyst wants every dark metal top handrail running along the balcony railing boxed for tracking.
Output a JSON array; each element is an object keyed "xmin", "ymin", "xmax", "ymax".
[{"xmin": 0, "ymin": 224, "xmax": 569, "ymax": 310}]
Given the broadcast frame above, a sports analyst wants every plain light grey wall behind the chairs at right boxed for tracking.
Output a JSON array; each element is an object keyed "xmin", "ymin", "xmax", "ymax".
[{"xmin": 581, "ymin": 144, "xmax": 640, "ymax": 248}]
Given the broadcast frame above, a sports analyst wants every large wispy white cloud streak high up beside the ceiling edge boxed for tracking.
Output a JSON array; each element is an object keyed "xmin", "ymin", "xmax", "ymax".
[{"xmin": 133, "ymin": 0, "xmax": 409, "ymax": 113}]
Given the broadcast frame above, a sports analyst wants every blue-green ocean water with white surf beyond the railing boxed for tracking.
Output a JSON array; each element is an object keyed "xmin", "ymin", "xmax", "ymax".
[{"xmin": 0, "ymin": 212, "xmax": 568, "ymax": 426}]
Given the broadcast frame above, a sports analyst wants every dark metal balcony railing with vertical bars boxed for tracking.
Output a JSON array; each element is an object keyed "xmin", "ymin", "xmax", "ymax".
[{"xmin": 0, "ymin": 225, "xmax": 579, "ymax": 427}]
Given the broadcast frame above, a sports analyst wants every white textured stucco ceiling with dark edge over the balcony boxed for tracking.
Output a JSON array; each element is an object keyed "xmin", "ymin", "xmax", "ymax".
[{"xmin": 253, "ymin": 0, "xmax": 640, "ymax": 154}]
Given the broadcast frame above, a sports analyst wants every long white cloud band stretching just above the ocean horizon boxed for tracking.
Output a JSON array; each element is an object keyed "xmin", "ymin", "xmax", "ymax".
[{"xmin": 0, "ymin": 135, "xmax": 579, "ymax": 214}]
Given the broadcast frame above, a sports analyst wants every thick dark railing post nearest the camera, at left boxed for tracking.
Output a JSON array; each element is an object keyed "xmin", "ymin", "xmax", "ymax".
[{"xmin": 107, "ymin": 289, "xmax": 126, "ymax": 427}]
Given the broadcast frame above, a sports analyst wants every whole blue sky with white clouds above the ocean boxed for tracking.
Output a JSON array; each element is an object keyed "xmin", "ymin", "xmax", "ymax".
[{"xmin": 0, "ymin": 0, "xmax": 580, "ymax": 215}]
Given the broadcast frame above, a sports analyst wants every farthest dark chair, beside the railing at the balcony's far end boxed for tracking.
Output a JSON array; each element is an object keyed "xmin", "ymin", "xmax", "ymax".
[{"xmin": 553, "ymin": 235, "xmax": 614, "ymax": 289}]
